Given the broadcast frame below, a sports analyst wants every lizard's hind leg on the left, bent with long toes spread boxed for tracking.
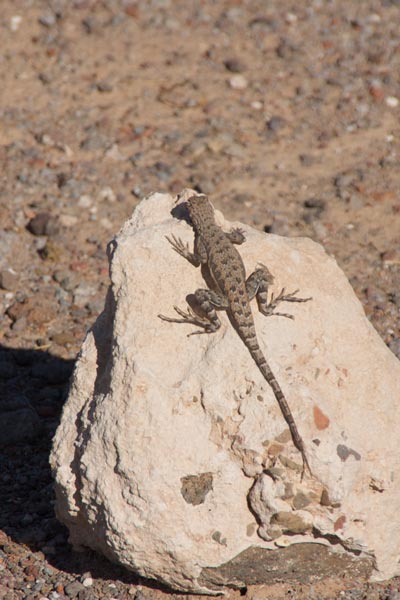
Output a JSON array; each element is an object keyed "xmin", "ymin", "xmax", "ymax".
[{"xmin": 158, "ymin": 289, "xmax": 228, "ymax": 336}]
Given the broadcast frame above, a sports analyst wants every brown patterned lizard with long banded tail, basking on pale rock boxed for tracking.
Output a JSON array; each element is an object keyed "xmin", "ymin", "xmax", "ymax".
[{"xmin": 158, "ymin": 194, "xmax": 312, "ymax": 478}]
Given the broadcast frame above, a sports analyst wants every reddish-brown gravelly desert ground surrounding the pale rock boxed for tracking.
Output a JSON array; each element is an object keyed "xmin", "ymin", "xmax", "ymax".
[{"xmin": 0, "ymin": 0, "xmax": 400, "ymax": 600}]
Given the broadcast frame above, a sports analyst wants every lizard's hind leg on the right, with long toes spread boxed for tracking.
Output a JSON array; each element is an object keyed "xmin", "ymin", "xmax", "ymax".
[{"xmin": 246, "ymin": 265, "xmax": 312, "ymax": 319}]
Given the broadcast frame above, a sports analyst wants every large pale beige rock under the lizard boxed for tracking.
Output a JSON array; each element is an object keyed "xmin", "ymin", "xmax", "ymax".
[{"xmin": 51, "ymin": 194, "xmax": 400, "ymax": 593}]
